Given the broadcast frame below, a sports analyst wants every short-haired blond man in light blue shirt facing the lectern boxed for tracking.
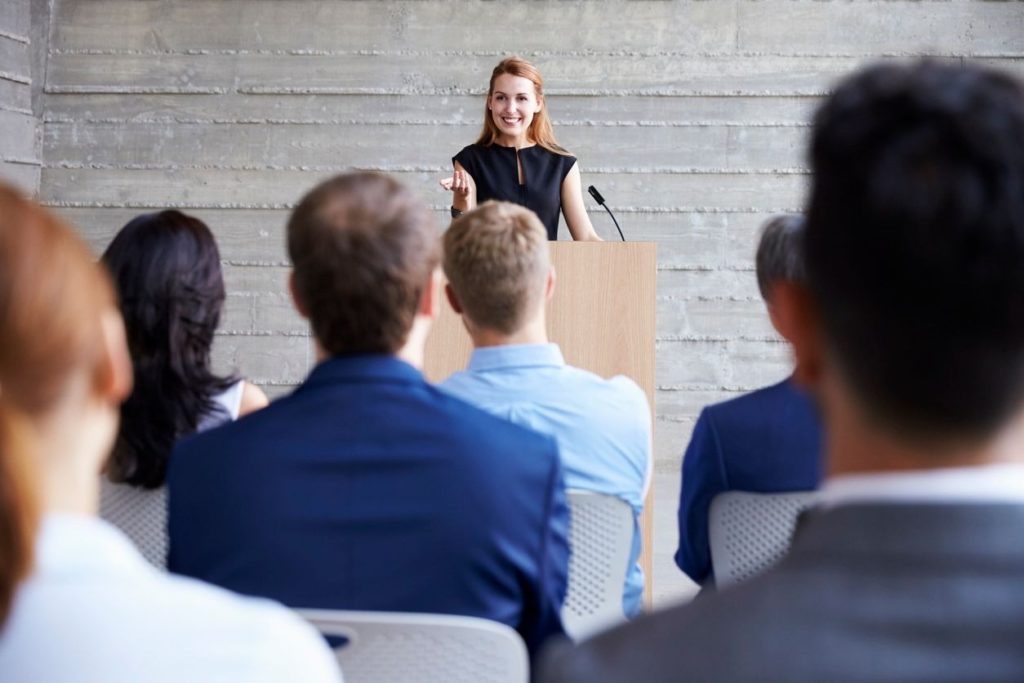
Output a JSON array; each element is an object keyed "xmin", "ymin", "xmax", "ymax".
[{"xmin": 441, "ymin": 202, "xmax": 651, "ymax": 616}]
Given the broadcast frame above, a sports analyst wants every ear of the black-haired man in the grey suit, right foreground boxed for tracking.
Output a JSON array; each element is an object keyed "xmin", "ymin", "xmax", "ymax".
[{"xmin": 769, "ymin": 282, "xmax": 824, "ymax": 390}]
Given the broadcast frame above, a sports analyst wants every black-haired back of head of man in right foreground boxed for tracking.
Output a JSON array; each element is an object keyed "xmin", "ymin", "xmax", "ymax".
[{"xmin": 806, "ymin": 61, "xmax": 1024, "ymax": 440}]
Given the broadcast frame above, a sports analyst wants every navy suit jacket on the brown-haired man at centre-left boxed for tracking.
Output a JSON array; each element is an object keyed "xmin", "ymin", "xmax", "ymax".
[{"xmin": 168, "ymin": 355, "xmax": 568, "ymax": 651}]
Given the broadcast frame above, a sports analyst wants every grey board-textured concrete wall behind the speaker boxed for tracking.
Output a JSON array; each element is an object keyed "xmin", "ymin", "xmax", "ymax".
[{"xmin": 36, "ymin": 0, "xmax": 1024, "ymax": 601}]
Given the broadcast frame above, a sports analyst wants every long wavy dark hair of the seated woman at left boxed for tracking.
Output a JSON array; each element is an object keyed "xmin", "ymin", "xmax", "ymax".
[{"xmin": 102, "ymin": 211, "xmax": 231, "ymax": 488}]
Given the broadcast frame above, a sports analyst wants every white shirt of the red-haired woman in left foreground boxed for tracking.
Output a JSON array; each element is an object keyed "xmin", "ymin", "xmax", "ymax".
[{"xmin": 0, "ymin": 515, "xmax": 341, "ymax": 683}]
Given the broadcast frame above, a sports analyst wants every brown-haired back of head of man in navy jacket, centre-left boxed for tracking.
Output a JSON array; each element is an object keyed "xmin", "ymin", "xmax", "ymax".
[{"xmin": 288, "ymin": 172, "xmax": 440, "ymax": 355}]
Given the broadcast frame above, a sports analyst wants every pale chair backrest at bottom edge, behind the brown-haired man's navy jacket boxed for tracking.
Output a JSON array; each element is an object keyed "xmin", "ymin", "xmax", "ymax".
[{"xmin": 297, "ymin": 609, "xmax": 529, "ymax": 683}]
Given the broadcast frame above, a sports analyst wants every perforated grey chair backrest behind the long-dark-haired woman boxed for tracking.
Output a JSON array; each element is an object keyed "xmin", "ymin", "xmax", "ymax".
[{"xmin": 99, "ymin": 477, "xmax": 167, "ymax": 569}]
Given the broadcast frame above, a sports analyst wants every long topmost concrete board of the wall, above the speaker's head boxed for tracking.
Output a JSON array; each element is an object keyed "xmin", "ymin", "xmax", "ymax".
[{"xmin": 53, "ymin": 0, "xmax": 735, "ymax": 52}]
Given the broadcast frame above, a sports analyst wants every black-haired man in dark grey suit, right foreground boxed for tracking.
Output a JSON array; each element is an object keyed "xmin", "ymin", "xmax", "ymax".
[{"xmin": 546, "ymin": 61, "xmax": 1024, "ymax": 683}]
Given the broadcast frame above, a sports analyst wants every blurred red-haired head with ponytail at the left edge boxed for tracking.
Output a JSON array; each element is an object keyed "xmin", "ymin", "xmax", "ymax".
[{"xmin": 0, "ymin": 181, "xmax": 114, "ymax": 621}]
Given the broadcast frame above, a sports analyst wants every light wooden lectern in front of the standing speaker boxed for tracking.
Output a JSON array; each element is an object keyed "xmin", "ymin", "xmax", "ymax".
[{"xmin": 424, "ymin": 242, "xmax": 657, "ymax": 608}]
